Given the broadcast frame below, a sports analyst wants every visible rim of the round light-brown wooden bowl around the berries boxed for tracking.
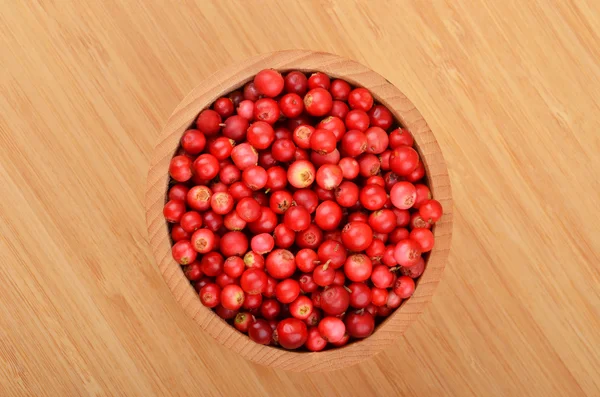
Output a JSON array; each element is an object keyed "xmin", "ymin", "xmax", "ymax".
[{"xmin": 146, "ymin": 50, "xmax": 452, "ymax": 372}]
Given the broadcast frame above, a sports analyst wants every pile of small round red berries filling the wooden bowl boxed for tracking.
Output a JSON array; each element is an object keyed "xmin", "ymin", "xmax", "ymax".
[{"xmin": 164, "ymin": 70, "xmax": 442, "ymax": 351}]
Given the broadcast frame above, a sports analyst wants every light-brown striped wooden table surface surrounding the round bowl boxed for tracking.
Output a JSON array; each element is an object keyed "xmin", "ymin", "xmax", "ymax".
[{"xmin": 0, "ymin": 0, "xmax": 600, "ymax": 397}]
